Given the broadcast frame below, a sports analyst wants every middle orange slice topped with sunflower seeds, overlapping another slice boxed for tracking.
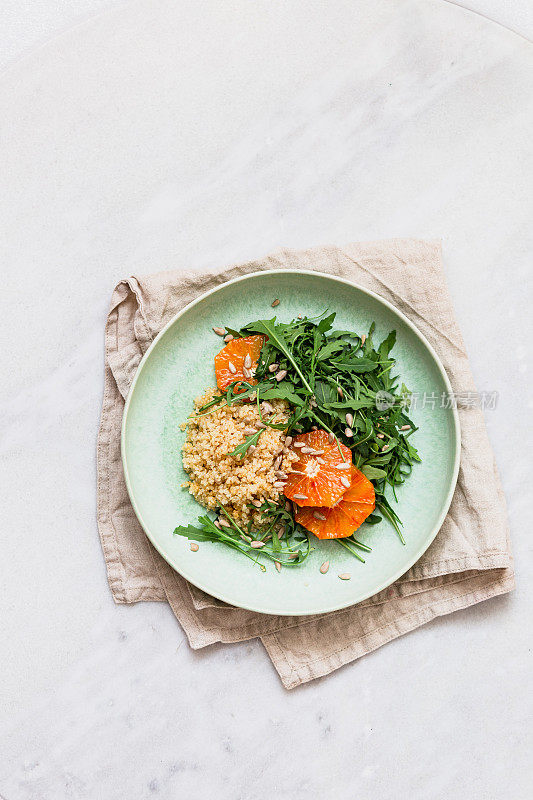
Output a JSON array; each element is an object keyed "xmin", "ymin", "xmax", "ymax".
[{"xmin": 284, "ymin": 431, "xmax": 352, "ymax": 508}]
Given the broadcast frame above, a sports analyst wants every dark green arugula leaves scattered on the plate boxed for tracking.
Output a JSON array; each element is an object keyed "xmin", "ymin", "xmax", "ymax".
[{"xmin": 175, "ymin": 313, "xmax": 420, "ymax": 566}]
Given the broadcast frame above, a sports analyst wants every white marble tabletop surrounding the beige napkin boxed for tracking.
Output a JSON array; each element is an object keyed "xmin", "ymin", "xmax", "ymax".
[{"xmin": 0, "ymin": 0, "xmax": 533, "ymax": 800}]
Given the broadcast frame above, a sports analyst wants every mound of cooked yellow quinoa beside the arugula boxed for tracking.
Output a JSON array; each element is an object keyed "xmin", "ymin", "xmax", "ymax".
[{"xmin": 183, "ymin": 388, "xmax": 298, "ymax": 525}]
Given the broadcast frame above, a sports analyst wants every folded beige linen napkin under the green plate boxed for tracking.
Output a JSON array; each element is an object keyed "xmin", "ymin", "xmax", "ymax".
[{"xmin": 97, "ymin": 239, "xmax": 514, "ymax": 689}]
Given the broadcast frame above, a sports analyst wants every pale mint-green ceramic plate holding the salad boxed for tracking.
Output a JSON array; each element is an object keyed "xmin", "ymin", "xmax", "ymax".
[{"xmin": 122, "ymin": 270, "xmax": 460, "ymax": 615}]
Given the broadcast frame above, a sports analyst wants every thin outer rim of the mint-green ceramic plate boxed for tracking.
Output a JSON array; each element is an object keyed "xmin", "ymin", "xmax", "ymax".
[{"xmin": 120, "ymin": 268, "xmax": 461, "ymax": 617}]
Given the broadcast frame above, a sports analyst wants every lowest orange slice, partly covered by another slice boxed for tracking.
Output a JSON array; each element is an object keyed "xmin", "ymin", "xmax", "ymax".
[{"xmin": 295, "ymin": 466, "xmax": 376, "ymax": 539}]
